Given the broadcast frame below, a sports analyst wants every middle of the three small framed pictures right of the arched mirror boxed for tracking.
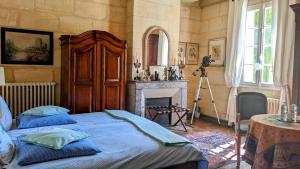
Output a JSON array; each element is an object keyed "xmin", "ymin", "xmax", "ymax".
[{"xmin": 185, "ymin": 43, "xmax": 199, "ymax": 65}]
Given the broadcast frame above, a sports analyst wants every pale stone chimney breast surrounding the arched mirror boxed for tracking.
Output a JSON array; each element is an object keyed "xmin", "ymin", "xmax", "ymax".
[{"xmin": 127, "ymin": 0, "xmax": 180, "ymax": 79}]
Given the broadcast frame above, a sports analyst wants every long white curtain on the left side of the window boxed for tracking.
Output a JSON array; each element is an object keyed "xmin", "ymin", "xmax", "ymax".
[{"xmin": 225, "ymin": 0, "xmax": 248, "ymax": 125}]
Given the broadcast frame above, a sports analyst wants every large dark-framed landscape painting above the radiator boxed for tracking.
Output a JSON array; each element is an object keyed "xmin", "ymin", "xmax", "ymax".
[{"xmin": 1, "ymin": 28, "xmax": 53, "ymax": 65}]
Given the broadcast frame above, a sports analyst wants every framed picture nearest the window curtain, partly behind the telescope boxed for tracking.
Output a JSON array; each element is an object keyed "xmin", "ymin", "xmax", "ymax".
[{"xmin": 208, "ymin": 38, "xmax": 226, "ymax": 66}]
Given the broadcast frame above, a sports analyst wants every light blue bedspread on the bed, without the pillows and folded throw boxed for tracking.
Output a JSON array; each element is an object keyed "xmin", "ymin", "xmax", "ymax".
[{"xmin": 5, "ymin": 112, "xmax": 207, "ymax": 169}]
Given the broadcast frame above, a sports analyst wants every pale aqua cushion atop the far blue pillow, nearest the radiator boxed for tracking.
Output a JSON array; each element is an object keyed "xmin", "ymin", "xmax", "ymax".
[{"xmin": 22, "ymin": 106, "xmax": 70, "ymax": 116}]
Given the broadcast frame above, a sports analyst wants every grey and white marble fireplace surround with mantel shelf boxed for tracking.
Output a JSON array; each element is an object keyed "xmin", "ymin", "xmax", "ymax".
[{"xmin": 127, "ymin": 80, "xmax": 188, "ymax": 123}]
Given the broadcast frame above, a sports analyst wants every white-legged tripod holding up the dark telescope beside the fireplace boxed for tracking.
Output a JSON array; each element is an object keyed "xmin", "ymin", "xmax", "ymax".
[{"xmin": 191, "ymin": 66, "xmax": 220, "ymax": 125}]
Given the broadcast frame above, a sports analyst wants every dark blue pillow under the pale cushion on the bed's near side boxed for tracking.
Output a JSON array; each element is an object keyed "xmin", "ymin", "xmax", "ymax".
[{"xmin": 16, "ymin": 136, "xmax": 101, "ymax": 166}]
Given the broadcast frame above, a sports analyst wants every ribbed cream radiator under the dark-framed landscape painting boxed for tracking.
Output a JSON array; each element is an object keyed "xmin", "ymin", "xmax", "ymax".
[{"xmin": 0, "ymin": 82, "xmax": 55, "ymax": 118}]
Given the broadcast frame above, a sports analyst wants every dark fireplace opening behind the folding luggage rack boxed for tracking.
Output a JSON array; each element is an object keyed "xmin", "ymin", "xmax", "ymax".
[{"xmin": 145, "ymin": 97, "xmax": 172, "ymax": 126}]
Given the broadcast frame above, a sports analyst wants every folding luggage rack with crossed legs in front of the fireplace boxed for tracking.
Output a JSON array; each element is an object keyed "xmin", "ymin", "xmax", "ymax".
[{"xmin": 147, "ymin": 105, "xmax": 190, "ymax": 132}]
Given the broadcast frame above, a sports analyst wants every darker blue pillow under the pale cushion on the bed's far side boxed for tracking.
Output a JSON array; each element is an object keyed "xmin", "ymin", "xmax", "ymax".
[{"xmin": 17, "ymin": 113, "xmax": 77, "ymax": 129}]
